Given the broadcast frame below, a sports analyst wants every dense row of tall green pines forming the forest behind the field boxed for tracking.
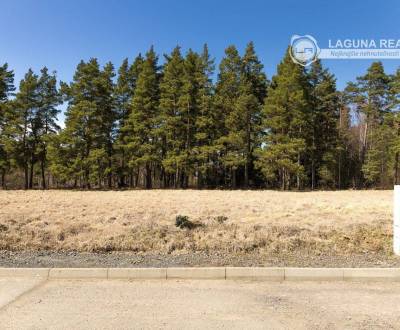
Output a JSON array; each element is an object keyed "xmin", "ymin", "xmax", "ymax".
[{"xmin": 0, "ymin": 43, "xmax": 400, "ymax": 190}]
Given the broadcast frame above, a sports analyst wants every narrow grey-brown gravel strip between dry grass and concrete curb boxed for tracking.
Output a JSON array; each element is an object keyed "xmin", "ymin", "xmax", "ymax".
[{"xmin": 0, "ymin": 251, "xmax": 400, "ymax": 267}]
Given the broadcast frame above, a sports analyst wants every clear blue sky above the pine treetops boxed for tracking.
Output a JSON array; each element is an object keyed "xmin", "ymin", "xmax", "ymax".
[{"xmin": 0, "ymin": 0, "xmax": 400, "ymax": 102}]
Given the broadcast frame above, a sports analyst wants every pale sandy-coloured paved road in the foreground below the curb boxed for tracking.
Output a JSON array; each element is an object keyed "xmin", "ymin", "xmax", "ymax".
[{"xmin": 0, "ymin": 278, "xmax": 400, "ymax": 329}]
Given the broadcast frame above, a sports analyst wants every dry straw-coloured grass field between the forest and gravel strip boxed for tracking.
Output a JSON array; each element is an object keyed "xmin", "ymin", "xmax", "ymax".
[{"xmin": 0, "ymin": 190, "xmax": 392, "ymax": 254}]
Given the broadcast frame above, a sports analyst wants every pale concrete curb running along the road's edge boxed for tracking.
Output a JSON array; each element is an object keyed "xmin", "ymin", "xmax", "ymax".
[{"xmin": 0, "ymin": 267, "xmax": 400, "ymax": 282}]
